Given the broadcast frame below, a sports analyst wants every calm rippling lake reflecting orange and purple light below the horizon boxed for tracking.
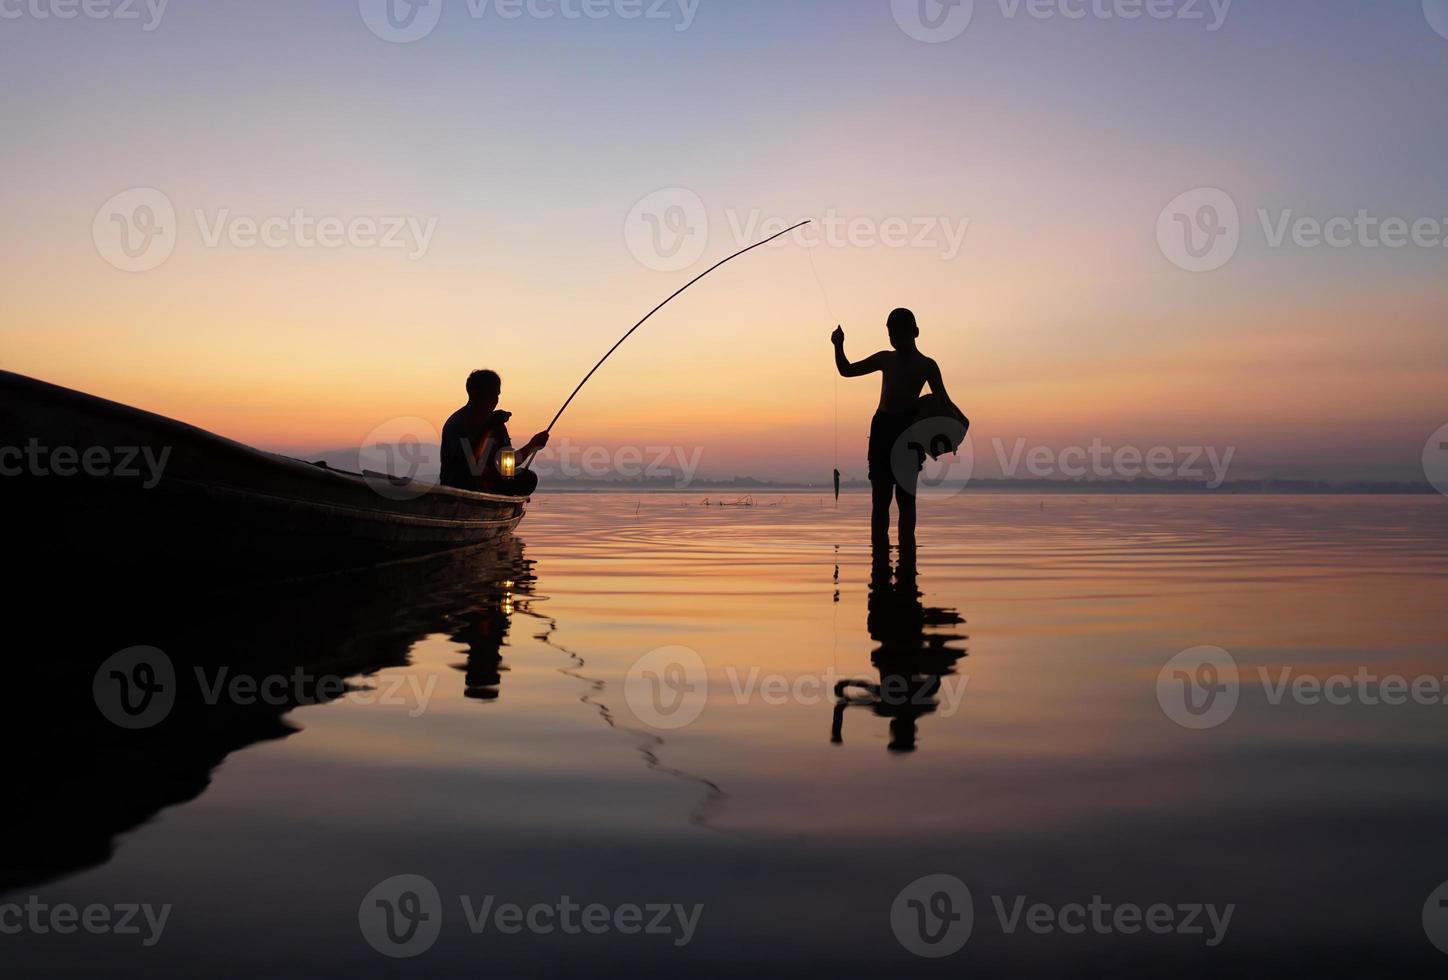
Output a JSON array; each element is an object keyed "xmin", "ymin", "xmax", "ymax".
[{"xmin": 8, "ymin": 494, "xmax": 1448, "ymax": 977}]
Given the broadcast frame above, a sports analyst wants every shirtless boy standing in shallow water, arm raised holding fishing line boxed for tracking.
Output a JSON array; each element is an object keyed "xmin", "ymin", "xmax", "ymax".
[{"xmin": 831, "ymin": 310, "xmax": 951, "ymax": 552}]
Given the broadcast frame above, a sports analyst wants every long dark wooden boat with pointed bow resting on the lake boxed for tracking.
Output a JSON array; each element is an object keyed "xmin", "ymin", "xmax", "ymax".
[{"xmin": 0, "ymin": 372, "xmax": 529, "ymax": 589}]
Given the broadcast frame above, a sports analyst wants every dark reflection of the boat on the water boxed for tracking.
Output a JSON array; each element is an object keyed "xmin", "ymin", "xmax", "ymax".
[{"xmin": 0, "ymin": 538, "xmax": 531, "ymax": 893}]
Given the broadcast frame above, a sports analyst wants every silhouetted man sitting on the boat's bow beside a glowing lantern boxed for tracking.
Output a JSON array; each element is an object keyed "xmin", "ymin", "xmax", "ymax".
[{"xmin": 442, "ymin": 371, "xmax": 547, "ymax": 497}]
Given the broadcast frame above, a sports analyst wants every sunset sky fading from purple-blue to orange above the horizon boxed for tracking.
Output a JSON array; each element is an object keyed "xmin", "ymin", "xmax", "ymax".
[{"xmin": 0, "ymin": 0, "xmax": 1448, "ymax": 479}]
